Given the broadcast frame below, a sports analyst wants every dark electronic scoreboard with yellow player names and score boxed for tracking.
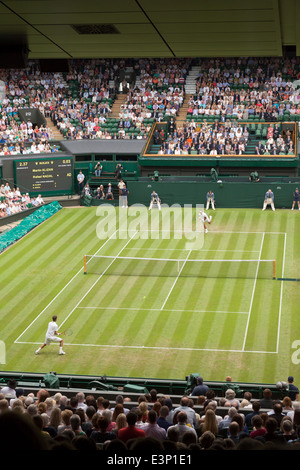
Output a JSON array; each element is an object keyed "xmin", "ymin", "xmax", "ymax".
[{"xmin": 14, "ymin": 157, "xmax": 73, "ymax": 194}]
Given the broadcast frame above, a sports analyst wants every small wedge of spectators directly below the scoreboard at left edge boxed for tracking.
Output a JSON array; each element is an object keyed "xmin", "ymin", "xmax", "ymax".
[{"xmin": 0, "ymin": 183, "xmax": 44, "ymax": 218}]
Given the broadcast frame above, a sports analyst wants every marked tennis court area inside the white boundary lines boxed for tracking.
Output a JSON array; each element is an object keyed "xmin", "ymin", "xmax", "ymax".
[{"xmin": 17, "ymin": 224, "xmax": 286, "ymax": 352}]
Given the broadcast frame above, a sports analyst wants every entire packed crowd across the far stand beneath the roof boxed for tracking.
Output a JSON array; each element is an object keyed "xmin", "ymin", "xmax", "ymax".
[{"xmin": 0, "ymin": 57, "xmax": 300, "ymax": 155}]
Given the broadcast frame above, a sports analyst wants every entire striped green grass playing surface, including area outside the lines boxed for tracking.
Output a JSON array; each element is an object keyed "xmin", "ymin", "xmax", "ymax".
[{"xmin": 0, "ymin": 207, "xmax": 300, "ymax": 383}]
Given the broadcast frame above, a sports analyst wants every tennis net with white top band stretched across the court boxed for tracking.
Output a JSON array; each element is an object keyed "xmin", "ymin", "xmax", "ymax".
[{"xmin": 84, "ymin": 255, "xmax": 276, "ymax": 279}]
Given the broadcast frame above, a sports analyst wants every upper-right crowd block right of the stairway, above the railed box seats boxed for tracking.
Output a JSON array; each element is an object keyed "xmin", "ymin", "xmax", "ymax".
[{"xmin": 188, "ymin": 57, "xmax": 300, "ymax": 121}]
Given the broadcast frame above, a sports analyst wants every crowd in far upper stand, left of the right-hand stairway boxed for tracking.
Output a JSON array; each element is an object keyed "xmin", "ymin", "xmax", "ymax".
[{"xmin": 0, "ymin": 59, "xmax": 190, "ymax": 141}]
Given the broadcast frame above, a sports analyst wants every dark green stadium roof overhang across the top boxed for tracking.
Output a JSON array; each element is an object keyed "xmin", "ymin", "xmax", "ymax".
[{"xmin": 0, "ymin": 0, "xmax": 300, "ymax": 59}]
